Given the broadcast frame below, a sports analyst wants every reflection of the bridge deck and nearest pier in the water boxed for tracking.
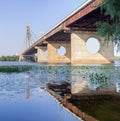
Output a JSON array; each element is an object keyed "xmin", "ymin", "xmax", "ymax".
[{"xmin": 46, "ymin": 67, "xmax": 120, "ymax": 121}]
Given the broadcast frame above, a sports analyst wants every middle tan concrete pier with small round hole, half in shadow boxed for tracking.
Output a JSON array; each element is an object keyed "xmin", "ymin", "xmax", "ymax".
[{"xmin": 47, "ymin": 41, "xmax": 71, "ymax": 63}]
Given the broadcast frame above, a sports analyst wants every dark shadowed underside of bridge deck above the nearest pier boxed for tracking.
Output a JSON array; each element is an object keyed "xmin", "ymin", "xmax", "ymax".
[{"xmin": 66, "ymin": 6, "xmax": 113, "ymax": 32}]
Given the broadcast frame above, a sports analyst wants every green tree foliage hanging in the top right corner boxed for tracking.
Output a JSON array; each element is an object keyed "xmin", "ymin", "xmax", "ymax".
[{"xmin": 97, "ymin": 0, "xmax": 120, "ymax": 51}]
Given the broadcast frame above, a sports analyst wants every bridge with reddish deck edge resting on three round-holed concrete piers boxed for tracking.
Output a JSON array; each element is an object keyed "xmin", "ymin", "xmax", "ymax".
[{"xmin": 21, "ymin": 0, "xmax": 114, "ymax": 63}]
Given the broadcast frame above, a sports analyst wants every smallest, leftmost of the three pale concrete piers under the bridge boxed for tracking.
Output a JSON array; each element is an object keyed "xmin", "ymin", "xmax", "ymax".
[{"xmin": 35, "ymin": 46, "xmax": 47, "ymax": 63}]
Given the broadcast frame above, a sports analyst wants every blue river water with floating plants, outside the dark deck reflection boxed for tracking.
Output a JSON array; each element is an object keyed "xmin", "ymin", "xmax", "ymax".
[{"xmin": 0, "ymin": 62, "xmax": 120, "ymax": 121}]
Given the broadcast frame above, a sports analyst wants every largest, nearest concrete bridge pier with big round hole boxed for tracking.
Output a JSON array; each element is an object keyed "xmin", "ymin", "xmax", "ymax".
[{"xmin": 71, "ymin": 32, "xmax": 114, "ymax": 64}]
